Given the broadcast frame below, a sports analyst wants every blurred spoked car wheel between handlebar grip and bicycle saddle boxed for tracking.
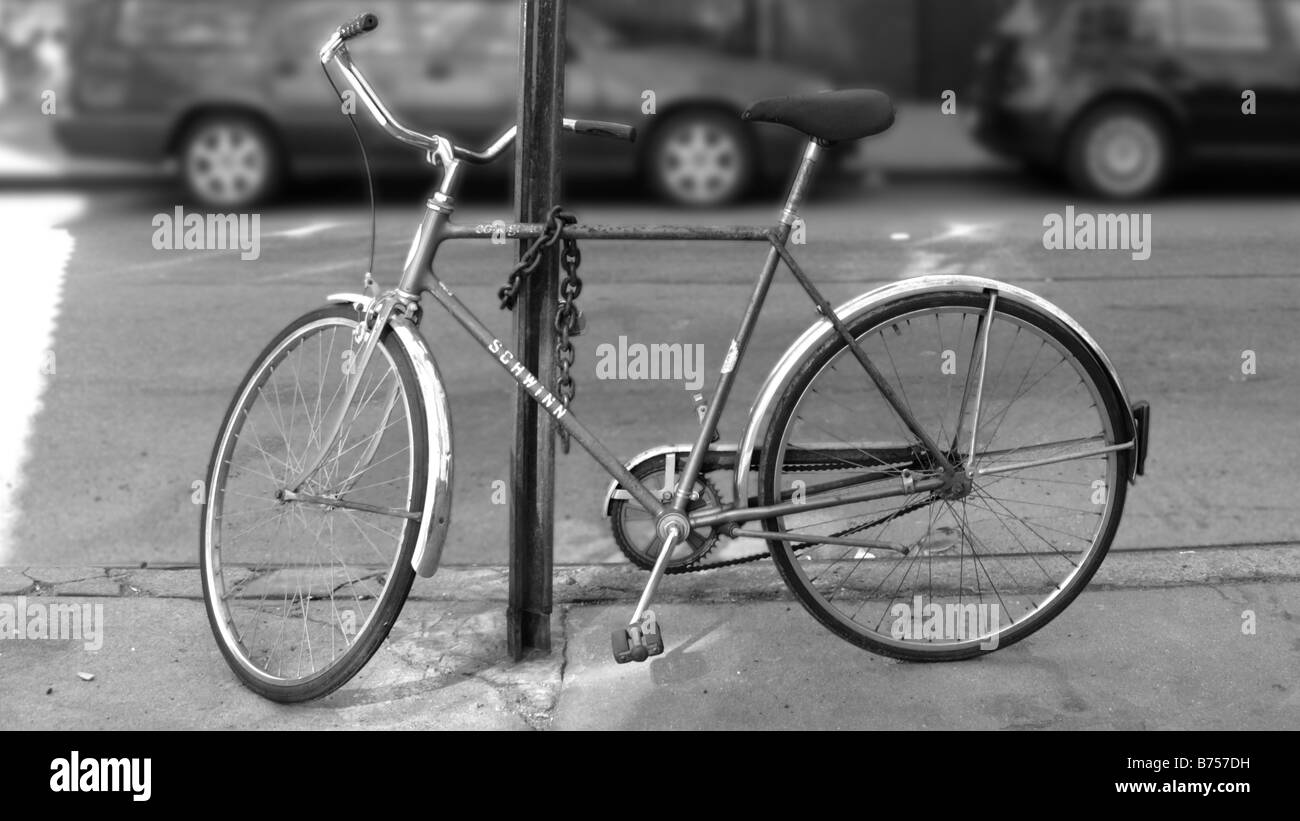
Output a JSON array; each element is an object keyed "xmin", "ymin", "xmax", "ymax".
[{"xmin": 658, "ymin": 120, "xmax": 745, "ymax": 205}]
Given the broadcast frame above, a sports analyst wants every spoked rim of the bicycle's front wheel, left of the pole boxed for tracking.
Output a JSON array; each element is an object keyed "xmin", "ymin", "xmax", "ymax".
[{"xmin": 204, "ymin": 317, "xmax": 417, "ymax": 687}]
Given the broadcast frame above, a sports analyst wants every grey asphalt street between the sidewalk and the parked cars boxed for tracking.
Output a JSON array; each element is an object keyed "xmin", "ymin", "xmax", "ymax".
[{"xmin": 0, "ymin": 178, "xmax": 1300, "ymax": 566}]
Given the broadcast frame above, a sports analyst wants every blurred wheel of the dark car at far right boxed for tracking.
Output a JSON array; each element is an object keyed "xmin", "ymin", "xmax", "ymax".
[{"xmin": 1066, "ymin": 103, "xmax": 1173, "ymax": 200}]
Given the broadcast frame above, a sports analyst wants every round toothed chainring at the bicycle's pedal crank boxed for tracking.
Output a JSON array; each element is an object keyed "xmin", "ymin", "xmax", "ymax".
[{"xmin": 610, "ymin": 455, "xmax": 722, "ymax": 570}]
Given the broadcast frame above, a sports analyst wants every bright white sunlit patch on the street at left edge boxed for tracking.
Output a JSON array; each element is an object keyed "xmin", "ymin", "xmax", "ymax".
[{"xmin": 0, "ymin": 195, "xmax": 85, "ymax": 565}]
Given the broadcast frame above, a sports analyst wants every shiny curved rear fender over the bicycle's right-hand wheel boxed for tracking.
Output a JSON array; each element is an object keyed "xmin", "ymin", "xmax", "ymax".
[{"xmin": 732, "ymin": 275, "xmax": 1145, "ymax": 507}]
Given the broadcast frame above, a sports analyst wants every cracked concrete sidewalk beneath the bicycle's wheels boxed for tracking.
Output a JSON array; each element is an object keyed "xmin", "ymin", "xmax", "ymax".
[{"xmin": 0, "ymin": 544, "xmax": 1300, "ymax": 730}]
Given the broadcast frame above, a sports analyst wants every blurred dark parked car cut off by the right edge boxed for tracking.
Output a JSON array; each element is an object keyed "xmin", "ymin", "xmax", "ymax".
[{"xmin": 972, "ymin": 0, "xmax": 1300, "ymax": 199}]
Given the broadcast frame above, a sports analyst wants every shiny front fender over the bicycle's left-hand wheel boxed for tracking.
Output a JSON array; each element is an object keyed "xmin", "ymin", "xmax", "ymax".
[{"xmin": 328, "ymin": 294, "xmax": 451, "ymax": 578}]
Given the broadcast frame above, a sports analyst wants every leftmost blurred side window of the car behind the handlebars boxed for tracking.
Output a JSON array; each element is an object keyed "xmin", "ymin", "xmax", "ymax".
[{"xmin": 117, "ymin": 0, "xmax": 256, "ymax": 48}]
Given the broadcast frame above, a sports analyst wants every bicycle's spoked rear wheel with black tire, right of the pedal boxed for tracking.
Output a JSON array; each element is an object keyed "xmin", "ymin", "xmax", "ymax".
[{"xmin": 759, "ymin": 291, "xmax": 1131, "ymax": 661}]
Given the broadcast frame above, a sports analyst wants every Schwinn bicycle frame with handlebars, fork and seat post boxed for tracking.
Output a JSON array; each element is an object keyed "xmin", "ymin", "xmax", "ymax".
[{"xmin": 309, "ymin": 35, "xmax": 1135, "ymax": 576}]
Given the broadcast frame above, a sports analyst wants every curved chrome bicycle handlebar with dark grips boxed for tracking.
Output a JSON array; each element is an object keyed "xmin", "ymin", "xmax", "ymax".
[{"xmin": 320, "ymin": 14, "xmax": 637, "ymax": 165}]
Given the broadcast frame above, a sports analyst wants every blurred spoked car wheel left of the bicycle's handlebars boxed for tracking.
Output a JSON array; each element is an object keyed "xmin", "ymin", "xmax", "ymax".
[{"xmin": 179, "ymin": 114, "xmax": 281, "ymax": 209}]
